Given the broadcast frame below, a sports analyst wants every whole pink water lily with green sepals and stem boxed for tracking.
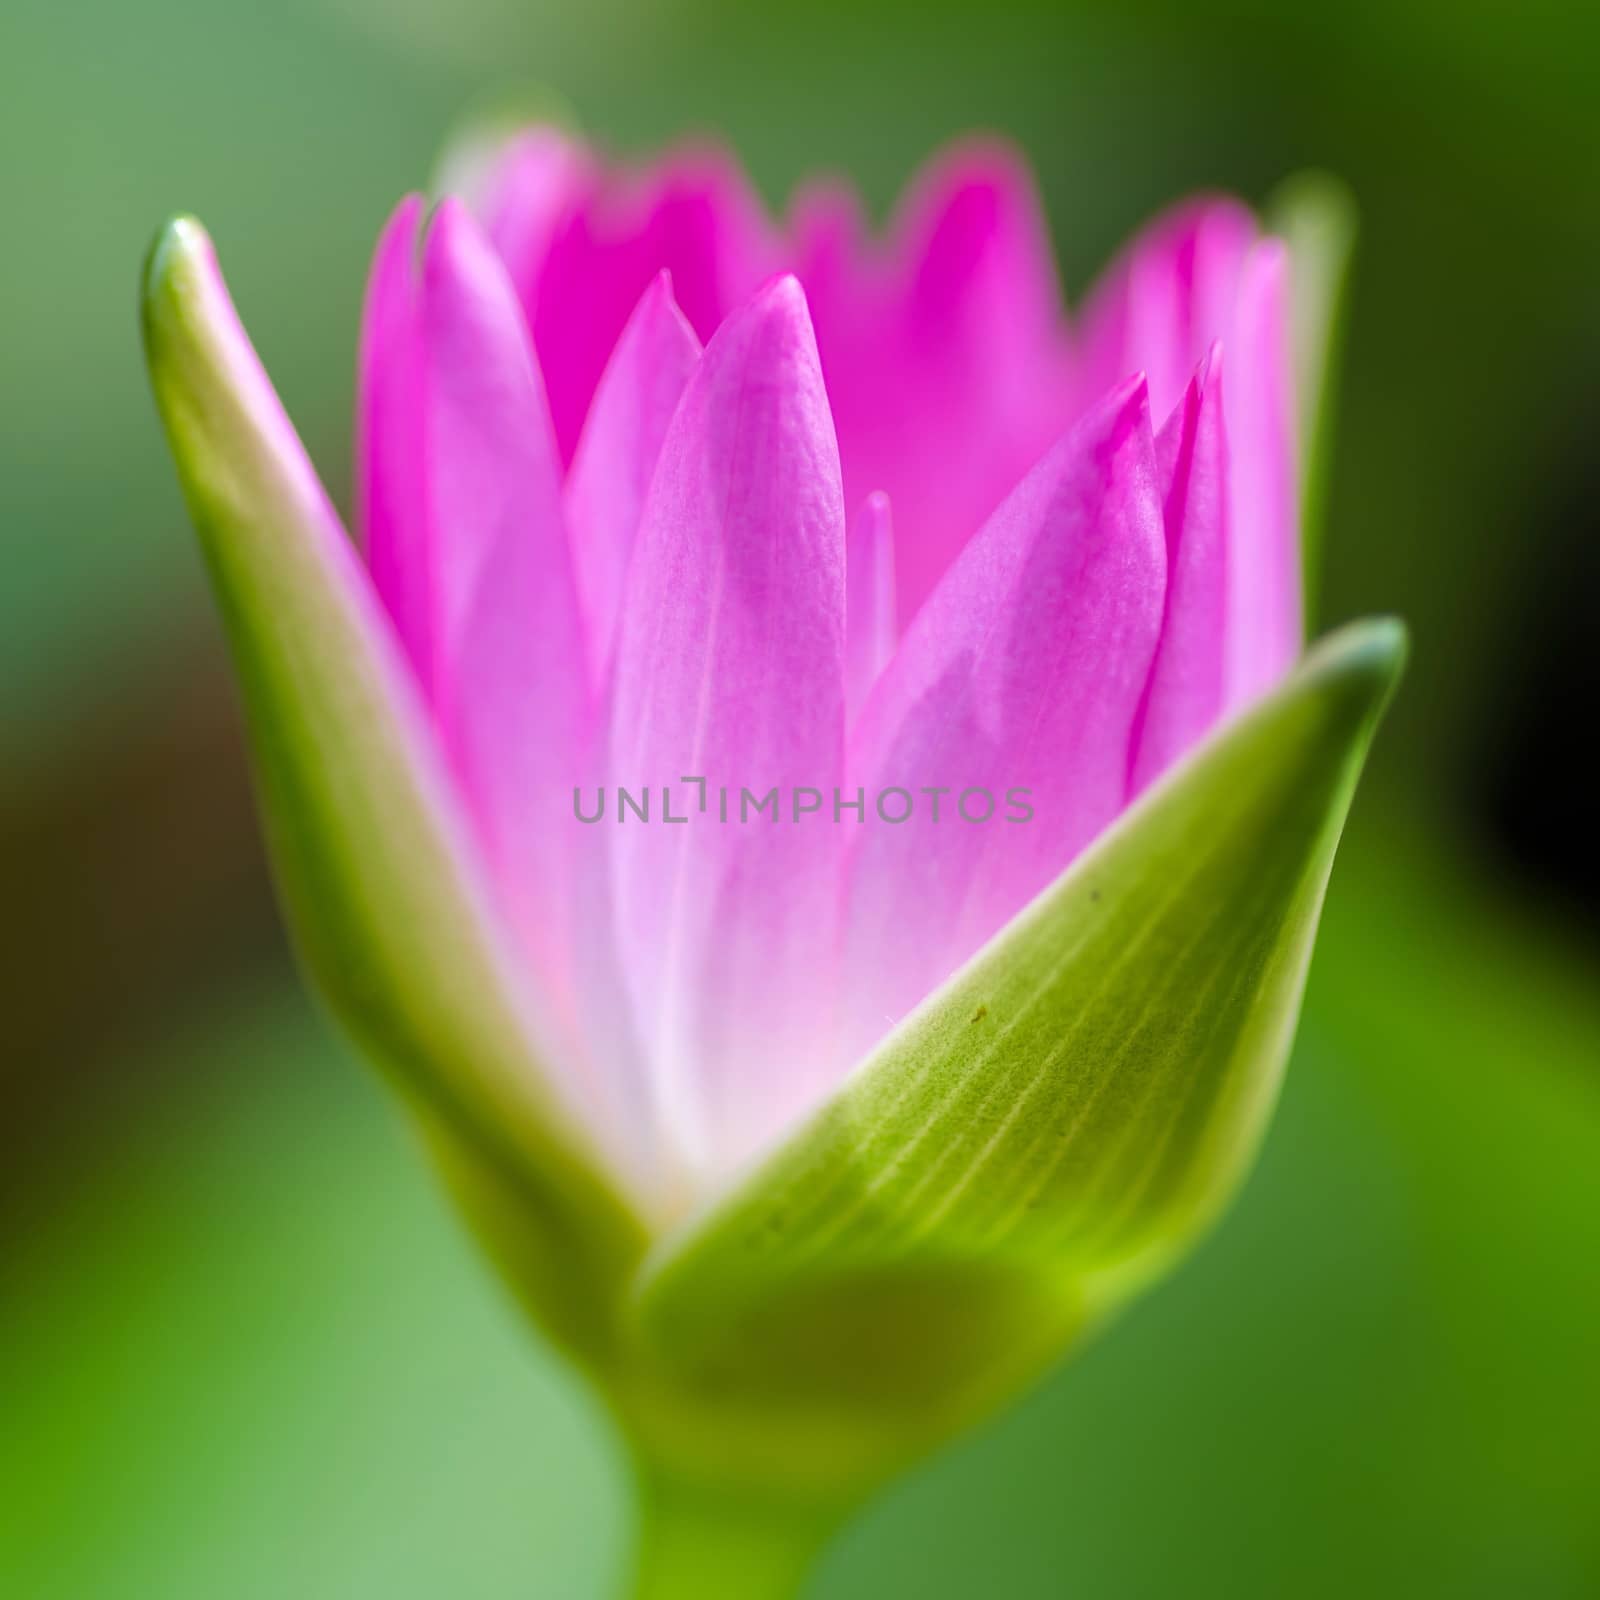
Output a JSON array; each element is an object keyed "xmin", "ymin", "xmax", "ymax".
[{"xmin": 144, "ymin": 128, "xmax": 1403, "ymax": 1595}]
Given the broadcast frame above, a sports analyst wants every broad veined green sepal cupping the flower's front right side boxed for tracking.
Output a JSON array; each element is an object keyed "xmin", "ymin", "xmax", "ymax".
[{"xmin": 637, "ymin": 621, "xmax": 1403, "ymax": 1493}]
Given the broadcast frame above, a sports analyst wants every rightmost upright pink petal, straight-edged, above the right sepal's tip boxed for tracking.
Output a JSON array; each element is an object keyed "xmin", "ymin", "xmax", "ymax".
[{"xmin": 1227, "ymin": 238, "xmax": 1301, "ymax": 706}]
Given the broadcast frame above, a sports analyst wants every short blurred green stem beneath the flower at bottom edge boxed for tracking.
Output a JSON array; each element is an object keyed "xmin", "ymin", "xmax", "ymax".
[{"xmin": 629, "ymin": 1467, "xmax": 835, "ymax": 1600}]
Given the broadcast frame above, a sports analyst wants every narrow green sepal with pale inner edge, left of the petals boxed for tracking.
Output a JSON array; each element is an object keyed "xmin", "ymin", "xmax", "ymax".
[{"xmin": 144, "ymin": 219, "xmax": 643, "ymax": 1357}]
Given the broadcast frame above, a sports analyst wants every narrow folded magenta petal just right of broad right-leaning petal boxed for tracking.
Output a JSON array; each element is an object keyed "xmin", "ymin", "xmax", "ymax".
[{"xmin": 1131, "ymin": 346, "xmax": 1227, "ymax": 794}]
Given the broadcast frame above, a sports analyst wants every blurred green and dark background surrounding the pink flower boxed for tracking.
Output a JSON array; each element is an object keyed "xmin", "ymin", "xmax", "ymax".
[{"xmin": 0, "ymin": 0, "xmax": 1600, "ymax": 1600}]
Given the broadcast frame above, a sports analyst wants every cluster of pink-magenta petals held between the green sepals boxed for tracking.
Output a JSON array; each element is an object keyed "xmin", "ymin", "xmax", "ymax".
[{"xmin": 358, "ymin": 130, "xmax": 1301, "ymax": 1203}]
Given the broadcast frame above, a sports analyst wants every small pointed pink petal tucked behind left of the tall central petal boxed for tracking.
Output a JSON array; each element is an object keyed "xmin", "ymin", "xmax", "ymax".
[{"xmin": 566, "ymin": 272, "xmax": 701, "ymax": 682}]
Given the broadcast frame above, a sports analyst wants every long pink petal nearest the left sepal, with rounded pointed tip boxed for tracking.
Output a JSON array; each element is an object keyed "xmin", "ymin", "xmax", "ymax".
[{"xmin": 422, "ymin": 200, "xmax": 586, "ymax": 976}]
